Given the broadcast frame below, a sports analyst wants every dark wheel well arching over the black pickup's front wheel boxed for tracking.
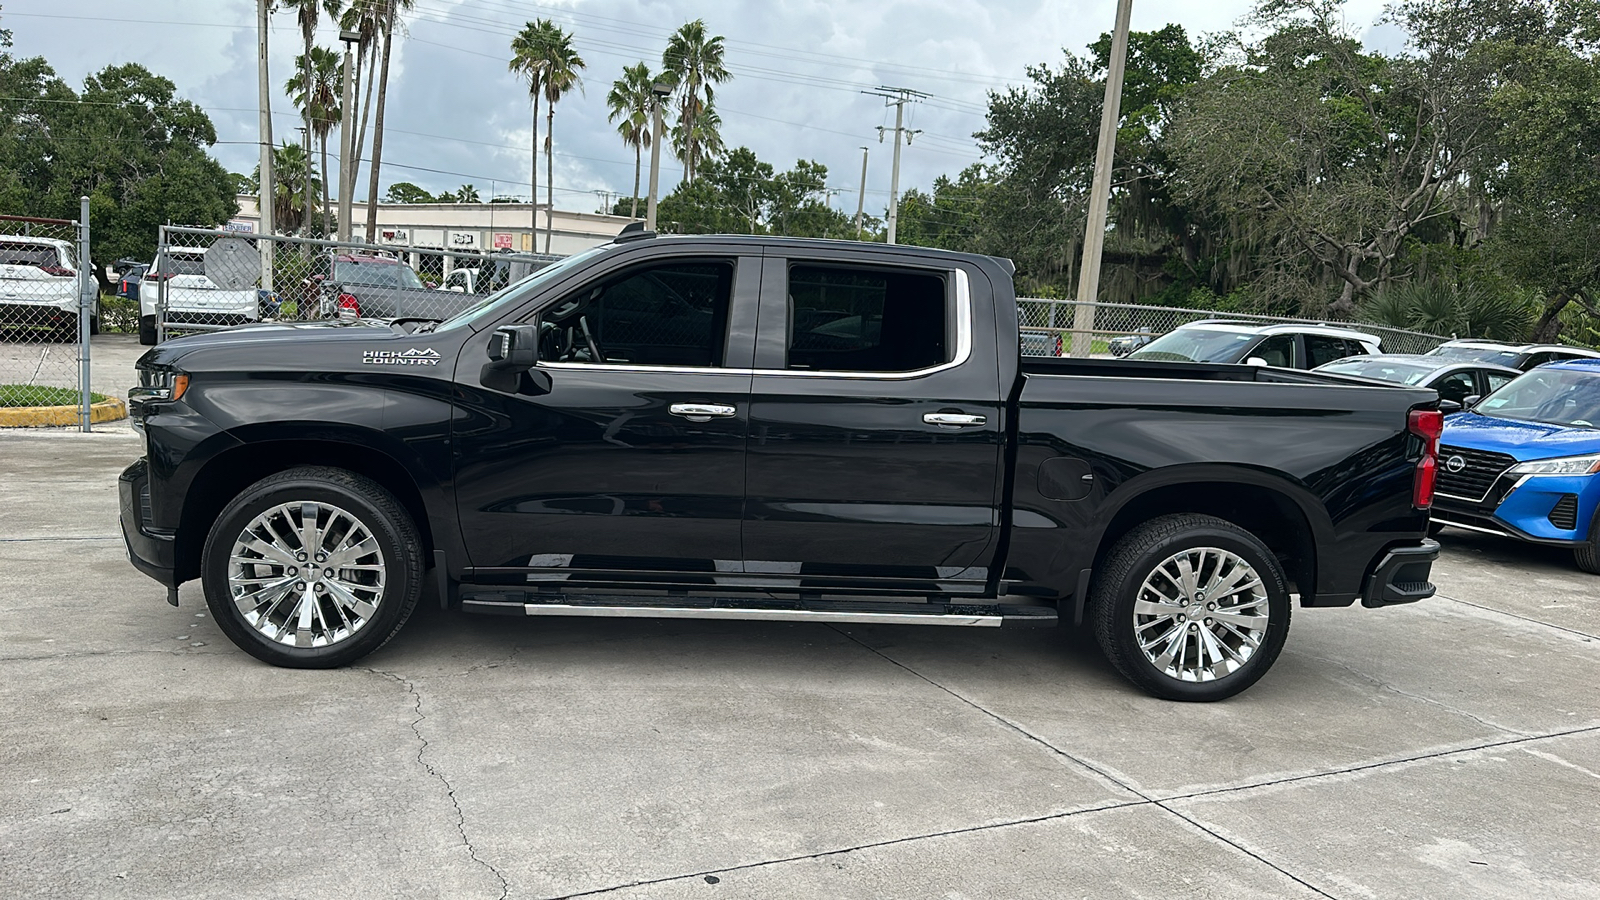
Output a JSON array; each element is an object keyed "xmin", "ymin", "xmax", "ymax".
[{"xmin": 174, "ymin": 440, "xmax": 434, "ymax": 581}]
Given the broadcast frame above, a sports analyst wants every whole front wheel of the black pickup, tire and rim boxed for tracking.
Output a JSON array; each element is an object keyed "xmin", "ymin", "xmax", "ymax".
[{"xmin": 200, "ymin": 466, "xmax": 422, "ymax": 669}]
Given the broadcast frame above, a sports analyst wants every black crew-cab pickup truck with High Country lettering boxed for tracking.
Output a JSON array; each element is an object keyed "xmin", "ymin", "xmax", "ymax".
[{"xmin": 120, "ymin": 232, "xmax": 1440, "ymax": 700}]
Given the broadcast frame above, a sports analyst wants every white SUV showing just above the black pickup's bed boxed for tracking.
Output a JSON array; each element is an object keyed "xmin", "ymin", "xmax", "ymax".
[{"xmin": 1125, "ymin": 319, "xmax": 1382, "ymax": 368}]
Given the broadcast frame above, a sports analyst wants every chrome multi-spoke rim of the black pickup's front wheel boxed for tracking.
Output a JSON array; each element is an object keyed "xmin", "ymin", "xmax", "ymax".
[{"xmin": 227, "ymin": 501, "xmax": 387, "ymax": 649}]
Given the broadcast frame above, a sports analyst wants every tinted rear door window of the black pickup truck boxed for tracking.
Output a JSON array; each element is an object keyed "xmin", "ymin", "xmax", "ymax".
[{"xmin": 789, "ymin": 264, "xmax": 950, "ymax": 372}]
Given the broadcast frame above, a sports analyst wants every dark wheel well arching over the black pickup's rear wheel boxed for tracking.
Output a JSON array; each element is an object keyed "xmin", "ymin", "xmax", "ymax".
[{"xmin": 1094, "ymin": 482, "xmax": 1317, "ymax": 597}]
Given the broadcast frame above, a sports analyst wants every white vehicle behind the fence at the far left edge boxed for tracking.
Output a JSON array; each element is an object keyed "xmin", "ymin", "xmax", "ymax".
[{"xmin": 0, "ymin": 234, "xmax": 99, "ymax": 343}]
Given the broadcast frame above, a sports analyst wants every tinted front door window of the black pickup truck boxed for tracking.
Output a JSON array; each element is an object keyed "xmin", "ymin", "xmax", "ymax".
[{"xmin": 539, "ymin": 261, "xmax": 733, "ymax": 368}]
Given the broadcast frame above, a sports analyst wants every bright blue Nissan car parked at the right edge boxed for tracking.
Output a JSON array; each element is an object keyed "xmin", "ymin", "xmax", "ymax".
[{"xmin": 1434, "ymin": 359, "xmax": 1600, "ymax": 575}]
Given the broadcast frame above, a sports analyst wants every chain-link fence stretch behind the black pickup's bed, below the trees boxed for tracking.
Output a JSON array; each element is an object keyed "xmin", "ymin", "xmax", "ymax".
[{"xmin": 1016, "ymin": 298, "xmax": 1450, "ymax": 357}]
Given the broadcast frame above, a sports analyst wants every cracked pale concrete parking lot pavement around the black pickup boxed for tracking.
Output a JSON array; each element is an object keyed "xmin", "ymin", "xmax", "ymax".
[{"xmin": 0, "ymin": 336, "xmax": 1600, "ymax": 898}]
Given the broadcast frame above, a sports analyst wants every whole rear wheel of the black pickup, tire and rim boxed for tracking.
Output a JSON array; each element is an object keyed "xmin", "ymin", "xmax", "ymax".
[{"xmin": 1088, "ymin": 514, "xmax": 1290, "ymax": 701}]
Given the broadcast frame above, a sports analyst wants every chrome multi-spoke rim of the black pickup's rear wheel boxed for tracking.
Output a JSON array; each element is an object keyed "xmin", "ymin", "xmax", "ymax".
[{"xmin": 1133, "ymin": 548, "xmax": 1272, "ymax": 682}]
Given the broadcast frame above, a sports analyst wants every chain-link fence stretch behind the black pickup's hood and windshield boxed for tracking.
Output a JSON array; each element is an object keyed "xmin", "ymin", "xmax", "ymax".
[{"xmin": 150, "ymin": 226, "xmax": 560, "ymax": 344}]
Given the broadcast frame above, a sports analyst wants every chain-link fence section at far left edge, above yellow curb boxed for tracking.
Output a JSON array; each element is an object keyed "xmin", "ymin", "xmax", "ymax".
[{"xmin": 0, "ymin": 202, "xmax": 95, "ymax": 431}]
